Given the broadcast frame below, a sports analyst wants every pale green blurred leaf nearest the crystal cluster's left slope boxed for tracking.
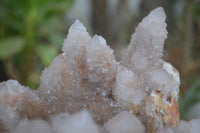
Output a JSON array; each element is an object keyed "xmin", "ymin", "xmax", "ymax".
[{"xmin": 36, "ymin": 45, "xmax": 58, "ymax": 66}]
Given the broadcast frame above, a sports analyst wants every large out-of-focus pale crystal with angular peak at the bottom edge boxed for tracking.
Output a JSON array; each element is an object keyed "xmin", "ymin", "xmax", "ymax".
[{"xmin": 53, "ymin": 110, "xmax": 100, "ymax": 133}]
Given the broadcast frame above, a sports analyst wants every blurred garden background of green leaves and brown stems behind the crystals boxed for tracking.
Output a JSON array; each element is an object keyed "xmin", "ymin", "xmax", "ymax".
[{"xmin": 0, "ymin": 0, "xmax": 200, "ymax": 119}]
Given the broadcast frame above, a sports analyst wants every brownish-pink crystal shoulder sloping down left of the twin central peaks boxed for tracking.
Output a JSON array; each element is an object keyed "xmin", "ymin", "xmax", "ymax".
[{"xmin": 37, "ymin": 54, "xmax": 73, "ymax": 98}]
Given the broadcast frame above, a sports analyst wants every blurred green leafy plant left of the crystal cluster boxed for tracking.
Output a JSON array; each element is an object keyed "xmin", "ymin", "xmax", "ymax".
[{"xmin": 0, "ymin": 0, "xmax": 73, "ymax": 88}]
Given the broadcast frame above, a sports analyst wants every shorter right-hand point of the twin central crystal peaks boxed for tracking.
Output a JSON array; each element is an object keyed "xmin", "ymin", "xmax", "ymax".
[{"xmin": 86, "ymin": 35, "xmax": 116, "ymax": 82}]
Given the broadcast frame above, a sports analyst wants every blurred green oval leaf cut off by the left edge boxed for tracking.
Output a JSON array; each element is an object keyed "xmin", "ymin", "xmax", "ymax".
[{"xmin": 0, "ymin": 37, "xmax": 25, "ymax": 59}]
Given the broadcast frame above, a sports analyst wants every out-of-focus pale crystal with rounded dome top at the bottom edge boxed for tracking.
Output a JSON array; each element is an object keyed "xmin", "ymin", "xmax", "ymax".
[{"xmin": 104, "ymin": 111, "xmax": 145, "ymax": 133}]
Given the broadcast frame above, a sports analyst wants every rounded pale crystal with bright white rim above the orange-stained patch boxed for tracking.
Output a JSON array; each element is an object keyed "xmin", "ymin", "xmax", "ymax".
[{"xmin": 142, "ymin": 61, "xmax": 180, "ymax": 99}]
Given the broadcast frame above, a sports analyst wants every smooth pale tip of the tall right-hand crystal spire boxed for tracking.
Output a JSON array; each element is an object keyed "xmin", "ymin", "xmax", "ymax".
[{"xmin": 148, "ymin": 7, "xmax": 166, "ymax": 22}]
